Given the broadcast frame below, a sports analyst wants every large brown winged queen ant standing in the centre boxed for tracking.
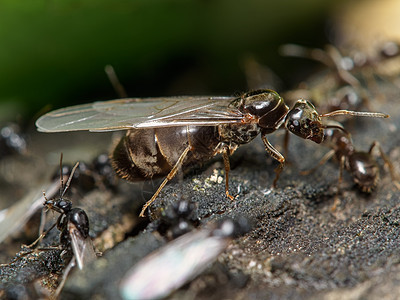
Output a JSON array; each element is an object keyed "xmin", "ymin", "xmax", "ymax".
[{"xmin": 36, "ymin": 90, "xmax": 387, "ymax": 216}]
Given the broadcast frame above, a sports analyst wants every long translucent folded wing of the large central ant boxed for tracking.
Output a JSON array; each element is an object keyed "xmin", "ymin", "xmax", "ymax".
[{"xmin": 36, "ymin": 96, "xmax": 242, "ymax": 132}]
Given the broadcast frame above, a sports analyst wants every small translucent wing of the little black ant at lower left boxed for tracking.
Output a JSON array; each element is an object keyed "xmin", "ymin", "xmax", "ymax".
[{"xmin": 68, "ymin": 222, "xmax": 96, "ymax": 270}]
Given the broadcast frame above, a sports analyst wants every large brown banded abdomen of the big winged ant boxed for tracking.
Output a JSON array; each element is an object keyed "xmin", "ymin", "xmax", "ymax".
[{"xmin": 112, "ymin": 126, "xmax": 220, "ymax": 181}]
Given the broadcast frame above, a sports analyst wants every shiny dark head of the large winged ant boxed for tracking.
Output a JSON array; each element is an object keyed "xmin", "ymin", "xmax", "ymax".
[{"xmin": 285, "ymin": 99, "xmax": 324, "ymax": 144}]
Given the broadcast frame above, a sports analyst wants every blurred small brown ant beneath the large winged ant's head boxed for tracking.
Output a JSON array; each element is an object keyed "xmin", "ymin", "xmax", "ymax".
[{"xmin": 301, "ymin": 122, "xmax": 400, "ymax": 193}]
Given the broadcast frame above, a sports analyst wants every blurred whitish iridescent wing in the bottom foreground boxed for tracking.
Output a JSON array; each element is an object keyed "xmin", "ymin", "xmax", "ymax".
[{"xmin": 120, "ymin": 230, "xmax": 230, "ymax": 299}]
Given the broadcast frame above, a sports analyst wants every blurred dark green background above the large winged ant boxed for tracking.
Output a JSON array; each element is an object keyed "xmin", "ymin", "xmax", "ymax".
[{"xmin": 0, "ymin": 0, "xmax": 344, "ymax": 120}]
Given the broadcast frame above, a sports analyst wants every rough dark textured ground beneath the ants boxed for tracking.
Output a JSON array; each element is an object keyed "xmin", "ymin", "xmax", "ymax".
[{"xmin": 0, "ymin": 73, "xmax": 400, "ymax": 299}]
